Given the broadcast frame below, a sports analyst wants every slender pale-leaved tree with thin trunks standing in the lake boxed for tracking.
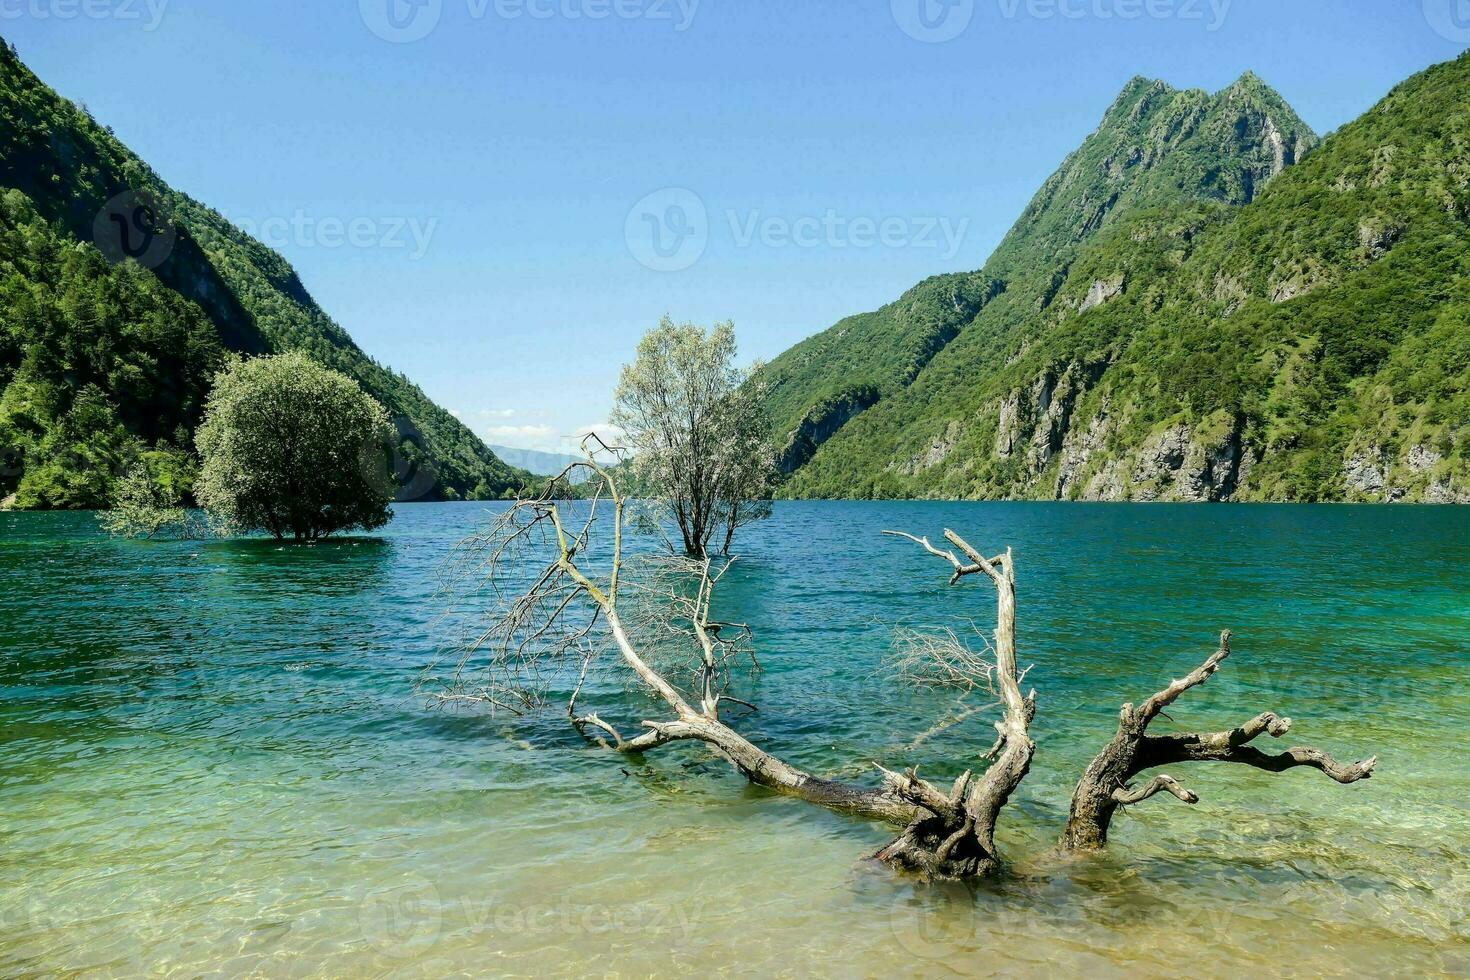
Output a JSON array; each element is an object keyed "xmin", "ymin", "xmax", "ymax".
[{"xmin": 612, "ymin": 316, "xmax": 775, "ymax": 557}]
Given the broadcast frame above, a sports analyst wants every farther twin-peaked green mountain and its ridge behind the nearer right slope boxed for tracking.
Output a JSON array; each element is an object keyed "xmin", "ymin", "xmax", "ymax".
[{"xmin": 766, "ymin": 75, "xmax": 1316, "ymax": 476}]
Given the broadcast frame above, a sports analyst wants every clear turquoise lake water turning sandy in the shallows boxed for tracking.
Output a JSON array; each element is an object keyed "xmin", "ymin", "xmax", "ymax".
[{"xmin": 0, "ymin": 502, "xmax": 1470, "ymax": 976}]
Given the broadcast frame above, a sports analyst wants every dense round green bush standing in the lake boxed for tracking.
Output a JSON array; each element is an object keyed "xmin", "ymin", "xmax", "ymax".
[{"xmin": 194, "ymin": 353, "xmax": 395, "ymax": 541}]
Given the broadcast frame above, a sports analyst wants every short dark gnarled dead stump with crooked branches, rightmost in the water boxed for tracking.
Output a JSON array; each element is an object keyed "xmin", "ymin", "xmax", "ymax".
[{"xmin": 1061, "ymin": 630, "xmax": 1377, "ymax": 851}]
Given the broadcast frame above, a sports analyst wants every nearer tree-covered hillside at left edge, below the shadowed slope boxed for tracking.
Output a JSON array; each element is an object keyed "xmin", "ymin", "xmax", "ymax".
[{"xmin": 0, "ymin": 190, "xmax": 225, "ymax": 507}]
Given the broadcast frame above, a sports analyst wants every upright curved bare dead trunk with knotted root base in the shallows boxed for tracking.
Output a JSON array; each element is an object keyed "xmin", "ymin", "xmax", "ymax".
[{"xmin": 875, "ymin": 530, "xmax": 1036, "ymax": 879}]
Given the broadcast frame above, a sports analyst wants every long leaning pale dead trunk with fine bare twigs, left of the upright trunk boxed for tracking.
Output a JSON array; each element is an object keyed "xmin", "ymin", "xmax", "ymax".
[{"xmin": 451, "ymin": 460, "xmax": 914, "ymax": 823}]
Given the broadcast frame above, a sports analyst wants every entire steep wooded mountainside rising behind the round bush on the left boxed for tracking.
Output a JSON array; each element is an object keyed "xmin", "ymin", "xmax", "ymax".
[{"xmin": 0, "ymin": 44, "xmax": 525, "ymax": 507}]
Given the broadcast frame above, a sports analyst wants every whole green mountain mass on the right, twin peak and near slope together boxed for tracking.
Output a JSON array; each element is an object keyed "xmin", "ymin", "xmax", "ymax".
[{"xmin": 772, "ymin": 56, "xmax": 1470, "ymax": 501}]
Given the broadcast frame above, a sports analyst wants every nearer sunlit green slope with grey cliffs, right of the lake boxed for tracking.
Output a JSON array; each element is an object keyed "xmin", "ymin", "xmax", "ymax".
[{"xmin": 786, "ymin": 56, "xmax": 1470, "ymax": 501}]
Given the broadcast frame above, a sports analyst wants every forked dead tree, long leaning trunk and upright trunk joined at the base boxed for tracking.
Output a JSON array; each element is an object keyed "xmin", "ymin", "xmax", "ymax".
[{"xmin": 435, "ymin": 443, "xmax": 1035, "ymax": 877}]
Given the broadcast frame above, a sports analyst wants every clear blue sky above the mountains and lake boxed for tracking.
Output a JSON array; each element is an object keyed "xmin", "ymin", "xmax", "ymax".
[{"xmin": 0, "ymin": 0, "xmax": 1470, "ymax": 448}]
